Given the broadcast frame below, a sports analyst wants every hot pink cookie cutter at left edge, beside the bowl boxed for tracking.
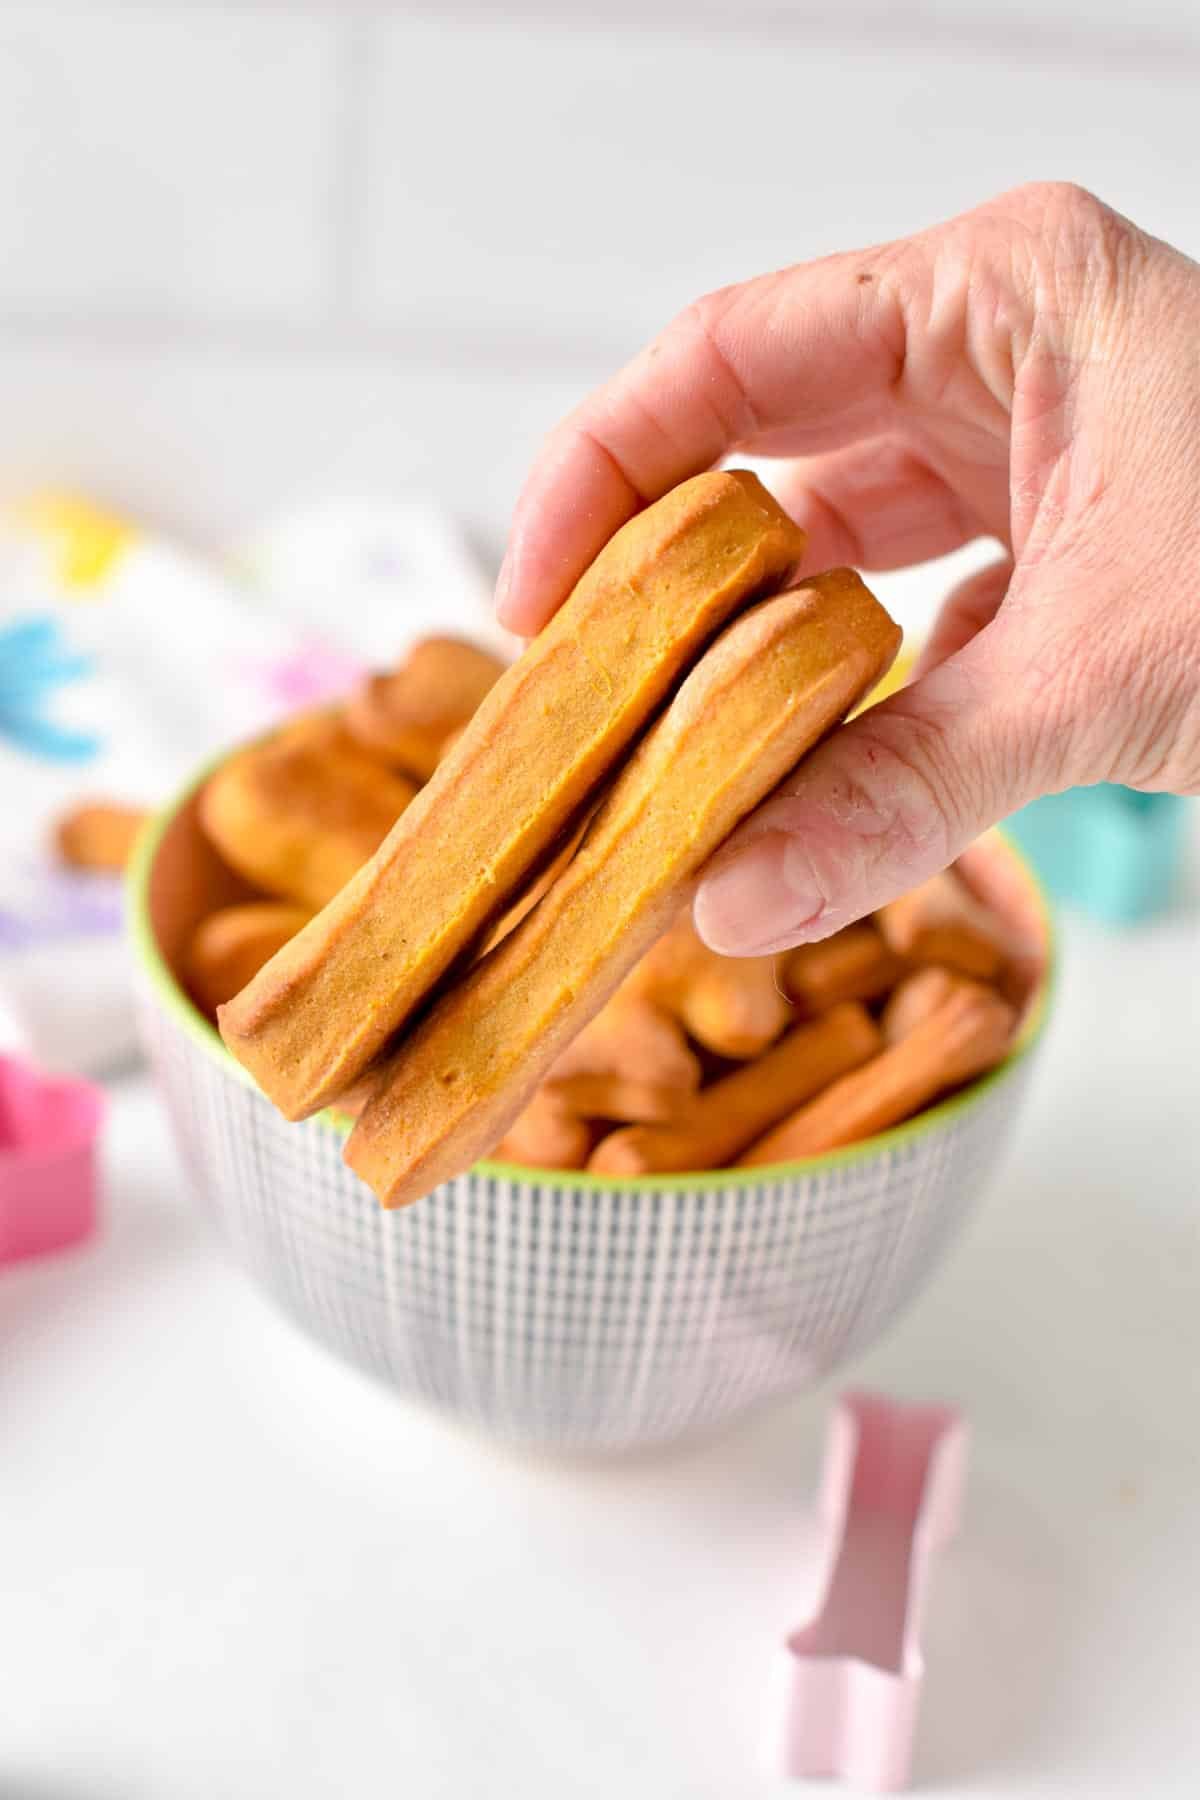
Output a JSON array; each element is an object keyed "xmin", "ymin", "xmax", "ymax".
[{"xmin": 0, "ymin": 1055, "xmax": 104, "ymax": 1265}]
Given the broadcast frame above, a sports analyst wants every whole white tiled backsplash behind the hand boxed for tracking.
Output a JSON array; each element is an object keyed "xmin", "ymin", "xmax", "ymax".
[{"xmin": 0, "ymin": 0, "xmax": 1200, "ymax": 533}]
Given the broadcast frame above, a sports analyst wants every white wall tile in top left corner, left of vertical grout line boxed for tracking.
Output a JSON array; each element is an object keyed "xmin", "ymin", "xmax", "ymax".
[{"xmin": 0, "ymin": 4, "xmax": 340, "ymax": 320}]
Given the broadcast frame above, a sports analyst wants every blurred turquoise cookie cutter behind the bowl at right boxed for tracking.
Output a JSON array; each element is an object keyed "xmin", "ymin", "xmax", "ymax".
[{"xmin": 1006, "ymin": 785, "xmax": 1189, "ymax": 925}]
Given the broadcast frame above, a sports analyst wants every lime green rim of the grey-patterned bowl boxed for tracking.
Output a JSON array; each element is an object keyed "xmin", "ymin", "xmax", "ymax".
[{"xmin": 126, "ymin": 756, "xmax": 1058, "ymax": 1193}]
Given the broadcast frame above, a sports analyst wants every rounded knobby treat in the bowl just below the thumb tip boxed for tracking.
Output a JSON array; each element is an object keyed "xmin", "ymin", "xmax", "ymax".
[{"xmin": 630, "ymin": 907, "xmax": 793, "ymax": 1058}]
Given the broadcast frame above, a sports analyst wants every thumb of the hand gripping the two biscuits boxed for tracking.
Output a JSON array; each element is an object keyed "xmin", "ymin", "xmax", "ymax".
[{"xmin": 694, "ymin": 621, "xmax": 1060, "ymax": 956}]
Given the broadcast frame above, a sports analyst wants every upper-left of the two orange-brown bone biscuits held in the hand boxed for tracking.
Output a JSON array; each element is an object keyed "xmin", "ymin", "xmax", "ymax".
[{"xmin": 221, "ymin": 472, "xmax": 804, "ymax": 1118}]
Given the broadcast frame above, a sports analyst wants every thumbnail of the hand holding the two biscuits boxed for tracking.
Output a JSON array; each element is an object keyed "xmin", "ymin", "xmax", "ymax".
[{"xmin": 694, "ymin": 832, "xmax": 826, "ymax": 956}]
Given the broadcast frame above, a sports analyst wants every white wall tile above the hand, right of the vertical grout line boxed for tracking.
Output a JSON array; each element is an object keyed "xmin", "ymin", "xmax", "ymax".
[{"xmin": 358, "ymin": 18, "xmax": 1200, "ymax": 346}]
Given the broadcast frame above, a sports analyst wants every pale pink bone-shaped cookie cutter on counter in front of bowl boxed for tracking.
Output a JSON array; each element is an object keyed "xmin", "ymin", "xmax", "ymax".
[{"xmin": 768, "ymin": 1393, "xmax": 966, "ymax": 1793}]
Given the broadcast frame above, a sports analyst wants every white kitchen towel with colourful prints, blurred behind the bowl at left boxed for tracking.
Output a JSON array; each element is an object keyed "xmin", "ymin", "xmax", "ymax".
[{"xmin": 0, "ymin": 493, "xmax": 511, "ymax": 1075}]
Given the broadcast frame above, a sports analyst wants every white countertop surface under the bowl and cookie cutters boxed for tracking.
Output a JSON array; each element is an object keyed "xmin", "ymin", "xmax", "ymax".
[{"xmin": 0, "ymin": 867, "xmax": 1200, "ymax": 1800}]
